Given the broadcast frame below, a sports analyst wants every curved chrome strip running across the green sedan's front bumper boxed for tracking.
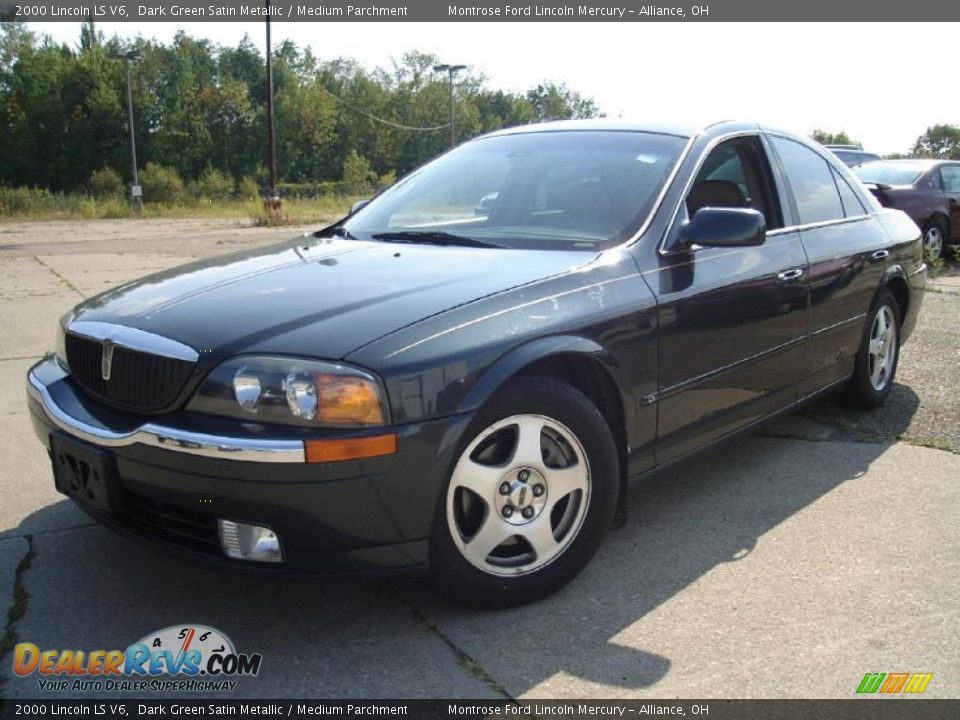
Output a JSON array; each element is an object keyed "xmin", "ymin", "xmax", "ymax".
[{"xmin": 27, "ymin": 370, "xmax": 306, "ymax": 463}]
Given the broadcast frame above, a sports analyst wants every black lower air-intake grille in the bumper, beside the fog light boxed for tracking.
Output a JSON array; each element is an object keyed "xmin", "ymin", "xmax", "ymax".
[{"xmin": 119, "ymin": 492, "xmax": 223, "ymax": 558}]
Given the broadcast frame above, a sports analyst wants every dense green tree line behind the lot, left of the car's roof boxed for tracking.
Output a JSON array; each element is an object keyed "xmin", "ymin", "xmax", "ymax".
[{"xmin": 0, "ymin": 22, "xmax": 600, "ymax": 199}]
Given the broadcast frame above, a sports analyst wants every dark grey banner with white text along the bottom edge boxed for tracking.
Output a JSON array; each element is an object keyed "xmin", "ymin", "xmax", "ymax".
[{"xmin": 0, "ymin": 698, "xmax": 960, "ymax": 720}]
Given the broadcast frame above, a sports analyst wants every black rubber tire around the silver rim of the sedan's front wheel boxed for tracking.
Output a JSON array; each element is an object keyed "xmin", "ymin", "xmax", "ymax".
[{"xmin": 430, "ymin": 377, "xmax": 619, "ymax": 608}]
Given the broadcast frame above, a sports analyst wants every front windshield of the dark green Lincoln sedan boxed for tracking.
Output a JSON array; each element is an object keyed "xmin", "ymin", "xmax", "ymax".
[{"xmin": 343, "ymin": 131, "xmax": 685, "ymax": 249}]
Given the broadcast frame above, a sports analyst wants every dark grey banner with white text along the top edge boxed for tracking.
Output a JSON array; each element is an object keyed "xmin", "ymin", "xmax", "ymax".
[{"xmin": 0, "ymin": 0, "xmax": 960, "ymax": 21}]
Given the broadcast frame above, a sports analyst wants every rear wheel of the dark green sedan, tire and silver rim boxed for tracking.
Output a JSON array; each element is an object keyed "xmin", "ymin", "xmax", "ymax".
[{"xmin": 849, "ymin": 290, "xmax": 900, "ymax": 410}]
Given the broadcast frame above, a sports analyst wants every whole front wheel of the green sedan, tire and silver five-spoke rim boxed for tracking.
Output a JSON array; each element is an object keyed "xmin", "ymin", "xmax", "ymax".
[{"xmin": 430, "ymin": 377, "xmax": 619, "ymax": 608}]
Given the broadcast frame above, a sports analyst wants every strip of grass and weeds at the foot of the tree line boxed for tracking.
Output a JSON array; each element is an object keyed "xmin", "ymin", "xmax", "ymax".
[{"xmin": 0, "ymin": 187, "xmax": 359, "ymax": 225}]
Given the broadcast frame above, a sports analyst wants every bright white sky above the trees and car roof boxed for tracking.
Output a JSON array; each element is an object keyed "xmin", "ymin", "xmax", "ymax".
[{"xmin": 28, "ymin": 22, "xmax": 960, "ymax": 153}]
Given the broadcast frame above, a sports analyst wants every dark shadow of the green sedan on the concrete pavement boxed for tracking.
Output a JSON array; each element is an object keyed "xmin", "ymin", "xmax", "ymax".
[{"xmin": 2, "ymin": 386, "xmax": 928, "ymax": 698}]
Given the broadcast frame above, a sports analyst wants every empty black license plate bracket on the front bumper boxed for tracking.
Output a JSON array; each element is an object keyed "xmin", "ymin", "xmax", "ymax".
[{"xmin": 50, "ymin": 433, "xmax": 119, "ymax": 514}]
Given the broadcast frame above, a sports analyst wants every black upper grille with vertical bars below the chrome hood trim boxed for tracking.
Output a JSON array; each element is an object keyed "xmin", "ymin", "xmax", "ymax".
[{"xmin": 66, "ymin": 332, "xmax": 194, "ymax": 412}]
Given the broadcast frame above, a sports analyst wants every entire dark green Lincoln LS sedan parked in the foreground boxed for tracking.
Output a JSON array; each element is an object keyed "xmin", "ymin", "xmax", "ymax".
[{"xmin": 27, "ymin": 121, "xmax": 926, "ymax": 606}]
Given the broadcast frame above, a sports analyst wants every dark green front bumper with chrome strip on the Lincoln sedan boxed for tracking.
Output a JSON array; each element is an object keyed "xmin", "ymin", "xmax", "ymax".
[{"xmin": 27, "ymin": 358, "xmax": 470, "ymax": 574}]
